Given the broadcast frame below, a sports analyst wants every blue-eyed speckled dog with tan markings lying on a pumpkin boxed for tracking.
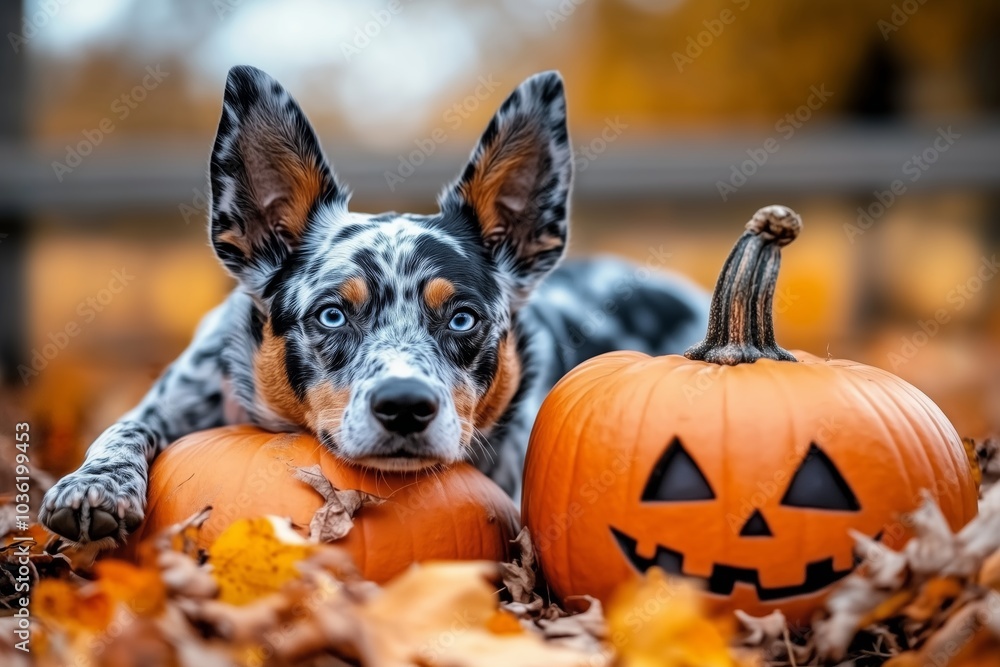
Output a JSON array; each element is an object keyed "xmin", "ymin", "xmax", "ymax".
[{"xmin": 39, "ymin": 66, "xmax": 708, "ymax": 550}]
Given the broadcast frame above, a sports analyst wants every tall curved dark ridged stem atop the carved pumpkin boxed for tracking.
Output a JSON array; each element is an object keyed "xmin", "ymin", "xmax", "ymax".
[{"xmin": 684, "ymin": 206, "xmax": 802, "ymax": 366}]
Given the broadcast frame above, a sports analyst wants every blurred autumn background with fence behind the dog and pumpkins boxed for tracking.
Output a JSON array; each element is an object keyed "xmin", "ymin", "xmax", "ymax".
[{"xmin": 0, "ymin": 0, "xmax": 1000, "ymax": 472}]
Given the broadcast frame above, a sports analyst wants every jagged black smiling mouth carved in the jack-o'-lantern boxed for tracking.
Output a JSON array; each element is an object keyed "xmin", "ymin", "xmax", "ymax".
[{"xmin": 611, "ymin": 528, "xmax": 882, "ymax": 602}]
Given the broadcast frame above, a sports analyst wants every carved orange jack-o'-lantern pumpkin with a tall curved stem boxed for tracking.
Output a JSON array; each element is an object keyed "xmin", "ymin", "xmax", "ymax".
[{"xmin": 522, "ymin": 206, "xmax": 977, "ymax": 621}]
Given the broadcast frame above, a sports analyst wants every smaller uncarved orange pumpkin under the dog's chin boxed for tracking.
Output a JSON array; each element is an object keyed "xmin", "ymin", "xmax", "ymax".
[{"xmin": 124, "ymin": 426, "xmax": 519, "ymax": 582}]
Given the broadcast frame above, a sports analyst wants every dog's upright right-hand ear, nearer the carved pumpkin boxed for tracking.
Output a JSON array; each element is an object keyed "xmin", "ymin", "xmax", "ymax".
[{"xmin": 439, "ymin": 72, "xmax": 573, "ymax": 298}]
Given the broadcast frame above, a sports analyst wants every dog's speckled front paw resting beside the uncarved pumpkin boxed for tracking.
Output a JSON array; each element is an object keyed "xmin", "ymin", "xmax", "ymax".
[{"xmin": 38, "ymin": 468, "xmax": 146, "ymax": 548}]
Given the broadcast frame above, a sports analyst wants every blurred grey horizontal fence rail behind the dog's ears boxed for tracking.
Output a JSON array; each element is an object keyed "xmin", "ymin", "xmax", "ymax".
[{"xmin": 0, "ymin": 120, "xmax": 1000, "ymax": 215}]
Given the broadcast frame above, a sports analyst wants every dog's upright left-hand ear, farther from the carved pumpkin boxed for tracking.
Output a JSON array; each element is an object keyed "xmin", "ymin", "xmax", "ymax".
[{"xmin": 209, "ymin": 66, "xmax": 347, "ymax": 294}]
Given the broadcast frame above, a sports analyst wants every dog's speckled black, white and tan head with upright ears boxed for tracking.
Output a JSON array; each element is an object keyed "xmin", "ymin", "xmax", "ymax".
[{"xmin": 210, "ymin": 67, "xmax": 572, "ymax": 469}]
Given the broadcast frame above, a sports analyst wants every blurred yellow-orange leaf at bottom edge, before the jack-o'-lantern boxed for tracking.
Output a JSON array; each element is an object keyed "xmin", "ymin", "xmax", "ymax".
[{"xmin": 608, "ymin": 568, "xmax": 739, "ymax": 667}]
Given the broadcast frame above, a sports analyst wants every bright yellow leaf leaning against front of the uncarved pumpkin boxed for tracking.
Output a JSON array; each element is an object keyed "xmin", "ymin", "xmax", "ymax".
[{"xmin": 208, "ymin": 517, "xmax": 317, "ymax": 605}]
